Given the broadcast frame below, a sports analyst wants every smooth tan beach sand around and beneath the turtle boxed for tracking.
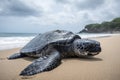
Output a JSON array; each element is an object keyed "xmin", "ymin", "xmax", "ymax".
[{"xmin": 0, "ymin": 35, "xmax": 120, "ymax": 80}]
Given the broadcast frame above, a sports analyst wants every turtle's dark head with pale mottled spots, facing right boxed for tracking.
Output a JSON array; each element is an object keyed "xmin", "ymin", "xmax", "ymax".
[{"xmin": 73, "ymin": 39, "xmax": 101, "ymax": 56}]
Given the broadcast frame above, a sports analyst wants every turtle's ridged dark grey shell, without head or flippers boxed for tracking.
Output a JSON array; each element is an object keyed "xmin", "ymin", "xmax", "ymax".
[{"xmin": 20, "ymin": 30, "xmax": 80, "ymax": 53}]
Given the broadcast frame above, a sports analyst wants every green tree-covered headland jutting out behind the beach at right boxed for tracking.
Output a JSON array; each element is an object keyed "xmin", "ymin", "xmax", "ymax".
[{"xmin": 80, "ymin": 18, "xmax": 120, "ymax": 33}]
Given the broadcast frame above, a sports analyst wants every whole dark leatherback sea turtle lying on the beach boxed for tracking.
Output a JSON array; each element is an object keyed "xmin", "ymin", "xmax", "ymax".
[{"xmin": 8, "ymin": 30, "xmax": 101, "ymax": 76}]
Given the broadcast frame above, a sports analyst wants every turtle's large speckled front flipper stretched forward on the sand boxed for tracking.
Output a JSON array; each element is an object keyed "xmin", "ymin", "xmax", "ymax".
[{"xmin": 20, "ymin": 51, "xmax": 61, "ymax": 76}]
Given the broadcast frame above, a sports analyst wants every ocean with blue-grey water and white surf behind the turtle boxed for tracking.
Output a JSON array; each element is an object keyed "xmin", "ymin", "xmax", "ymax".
[{"xmin": 0, "ymin": 33, "xmax": 117, "ymax": 50}]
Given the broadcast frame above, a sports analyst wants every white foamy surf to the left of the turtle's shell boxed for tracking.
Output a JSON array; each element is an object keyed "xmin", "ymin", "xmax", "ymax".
[{"xmin": 0, "ymin": 37, "xmax": 33, "ymax": 50}]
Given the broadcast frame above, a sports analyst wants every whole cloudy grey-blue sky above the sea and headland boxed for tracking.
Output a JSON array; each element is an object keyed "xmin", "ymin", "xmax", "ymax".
[{"xmin": 0, "ymin": 0, "xmax": 120, "ymax": 33}]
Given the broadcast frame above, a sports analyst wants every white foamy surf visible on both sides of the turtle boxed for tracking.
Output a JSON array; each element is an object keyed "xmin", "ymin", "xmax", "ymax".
[{"xmin": 0, "ymin": 34, "xmax": 116, "ymax": 50}]
